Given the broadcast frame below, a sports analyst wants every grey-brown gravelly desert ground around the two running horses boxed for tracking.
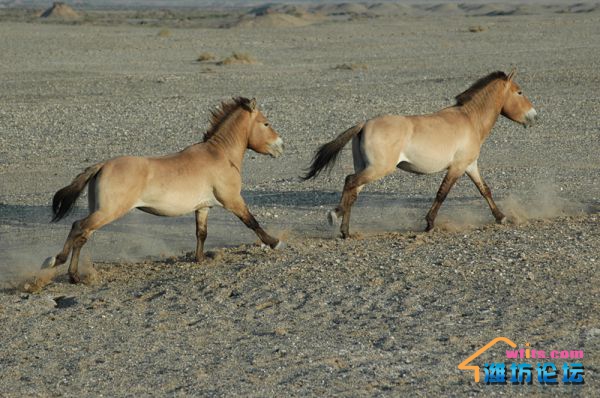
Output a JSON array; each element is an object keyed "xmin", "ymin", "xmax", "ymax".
[{"xmin": 0, "ymin": 2, "xmax": 600, "ymax": 397}]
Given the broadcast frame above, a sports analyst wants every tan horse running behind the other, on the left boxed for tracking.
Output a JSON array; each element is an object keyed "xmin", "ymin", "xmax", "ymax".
[{"xmin": 44, "ymin": 98, "xmax": 284, "ymax": 283}]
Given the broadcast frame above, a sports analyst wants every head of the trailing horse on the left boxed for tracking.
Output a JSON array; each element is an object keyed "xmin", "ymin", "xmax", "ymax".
[{"xmin": 243, "ymin": 98, "xmax": 283, "ymax": 158}]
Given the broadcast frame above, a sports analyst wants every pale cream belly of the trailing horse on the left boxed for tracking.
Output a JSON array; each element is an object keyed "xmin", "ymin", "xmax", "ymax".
[{"xmin": 135, "ymin": 192, "xmax": 221, "ymax": 217}]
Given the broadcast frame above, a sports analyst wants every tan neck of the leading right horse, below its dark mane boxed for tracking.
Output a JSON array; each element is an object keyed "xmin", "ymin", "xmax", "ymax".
[{"xmin": 462, "ymin": 83, "xmax": 504, "ymax": 142}]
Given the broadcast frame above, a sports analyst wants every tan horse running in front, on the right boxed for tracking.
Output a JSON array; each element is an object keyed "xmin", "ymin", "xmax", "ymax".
[{"xmin": 303, "ymin": 71, "xmax": 537, "ymax": 238}]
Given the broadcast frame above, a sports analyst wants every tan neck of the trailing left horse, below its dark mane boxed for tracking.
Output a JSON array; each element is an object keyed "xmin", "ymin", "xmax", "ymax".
[{"xmin": 207, "ymin": 115, "xmax": 248, "ymax": 170}]
